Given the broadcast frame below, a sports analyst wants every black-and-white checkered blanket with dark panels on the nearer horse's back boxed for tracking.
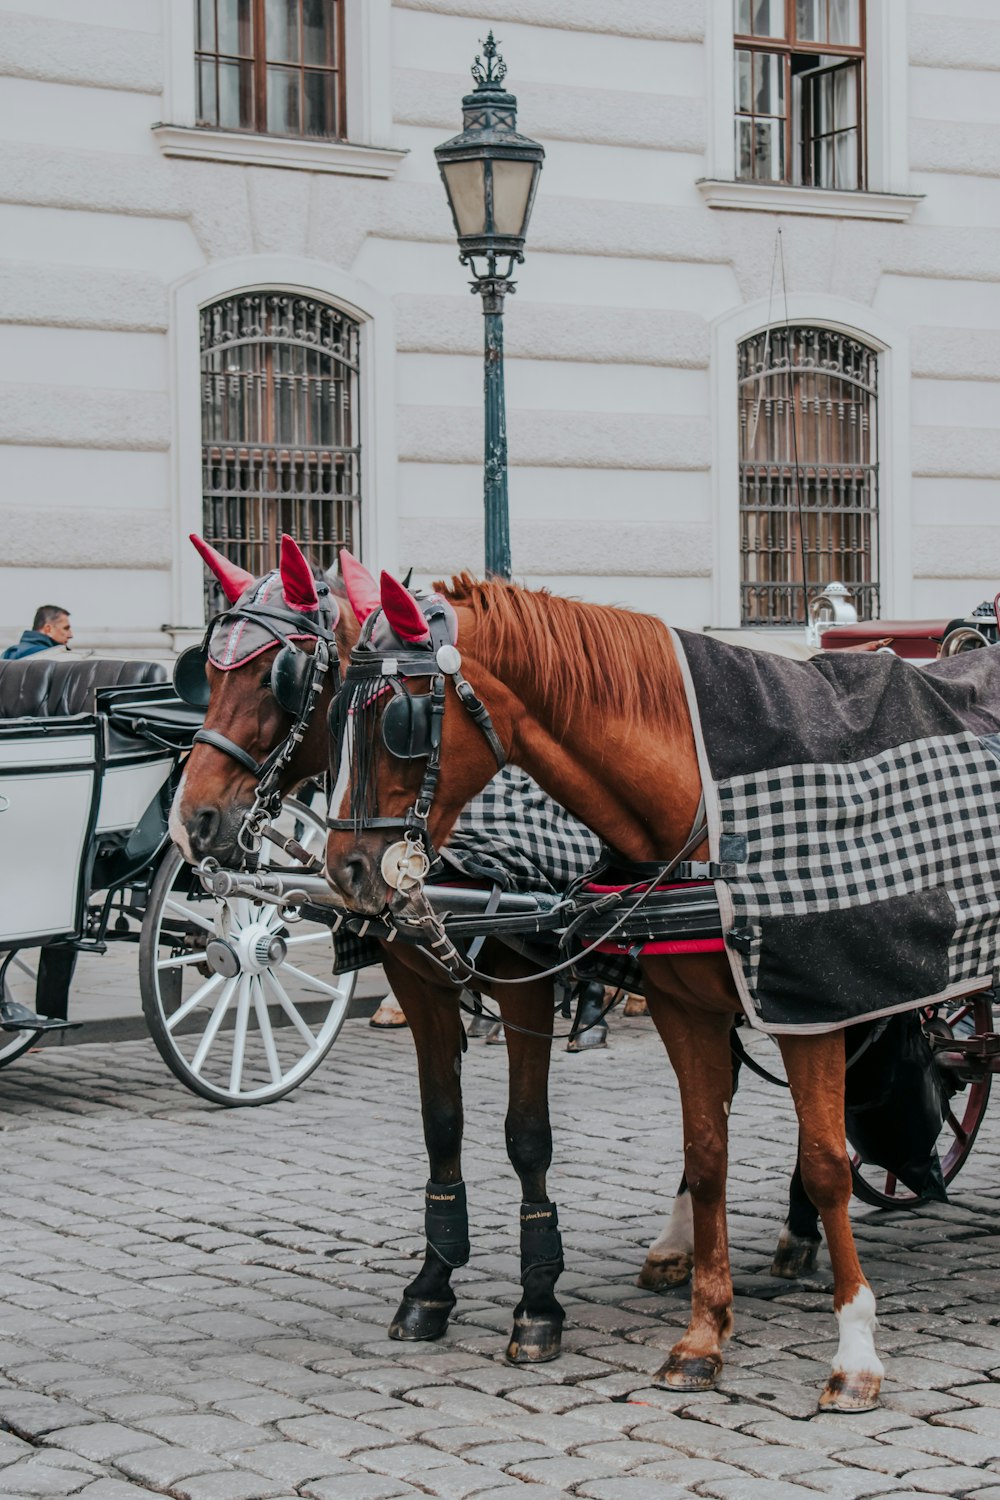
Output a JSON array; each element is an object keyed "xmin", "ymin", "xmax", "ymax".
[{"xmin": 673, "ymin": 632, "xmax": 1000, "ymax": 1032}]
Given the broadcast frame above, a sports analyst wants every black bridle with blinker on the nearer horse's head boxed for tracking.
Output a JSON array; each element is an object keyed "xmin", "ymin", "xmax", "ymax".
[{"xmin": 327, "ymin": 599, "xmax": 507, "ymax": 891}]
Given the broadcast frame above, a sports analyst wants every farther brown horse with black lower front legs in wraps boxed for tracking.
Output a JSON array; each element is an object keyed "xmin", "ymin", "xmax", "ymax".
[{"xmin": 171, "ymin": 542, "xmax": 819, "ymax": 1362}]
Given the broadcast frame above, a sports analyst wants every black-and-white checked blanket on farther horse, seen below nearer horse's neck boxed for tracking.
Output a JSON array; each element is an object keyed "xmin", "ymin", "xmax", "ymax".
[{"xmin": 333, "ymin": 765, "xmax": 605, "ymax": 984}]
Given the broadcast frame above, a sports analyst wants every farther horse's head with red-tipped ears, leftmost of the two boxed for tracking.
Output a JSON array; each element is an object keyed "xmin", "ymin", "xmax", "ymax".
[{"xmin": 169, "ymin": 536, "xmax": 357, "ymax": 864}]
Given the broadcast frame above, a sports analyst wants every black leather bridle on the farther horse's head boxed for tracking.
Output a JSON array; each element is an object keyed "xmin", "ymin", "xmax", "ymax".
[{"xmin": 174, "ymin": 584, "xmax": 340, "ymax": 854}]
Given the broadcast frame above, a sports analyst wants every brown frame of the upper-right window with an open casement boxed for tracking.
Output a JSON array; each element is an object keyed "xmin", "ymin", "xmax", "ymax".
[{"xmin": 733, "ymin": 0, "xmax": 868, "ymax": 192}]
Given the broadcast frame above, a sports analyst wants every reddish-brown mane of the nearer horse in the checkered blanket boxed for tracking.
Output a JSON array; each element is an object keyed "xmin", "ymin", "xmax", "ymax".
[{"xmin": 435, "ymin": 573, "xmax": 687, "ymax": 728}]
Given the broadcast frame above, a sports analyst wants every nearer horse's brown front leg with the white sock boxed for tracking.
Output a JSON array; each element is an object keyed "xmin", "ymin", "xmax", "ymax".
[{"xmin": 778, "ymin": 1032, "xmax": 885, "ymax": 1412}]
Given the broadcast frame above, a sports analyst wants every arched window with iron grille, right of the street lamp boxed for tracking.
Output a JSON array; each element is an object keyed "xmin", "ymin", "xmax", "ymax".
[{"xmin": 739, "ymin": 326, "xmax": 879, "ymax": 626}]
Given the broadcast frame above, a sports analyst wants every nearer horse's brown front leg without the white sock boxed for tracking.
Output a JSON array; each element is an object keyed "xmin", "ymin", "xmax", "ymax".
[{"xmin": 648, "ymin": 986, "xmax": 733, "ymax": 1391}]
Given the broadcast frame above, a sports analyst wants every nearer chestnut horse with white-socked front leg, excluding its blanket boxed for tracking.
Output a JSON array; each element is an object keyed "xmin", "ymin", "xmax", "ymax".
[{"xmin": 327, "ymin": 575, "xmax": 883, "ymax": 1410}]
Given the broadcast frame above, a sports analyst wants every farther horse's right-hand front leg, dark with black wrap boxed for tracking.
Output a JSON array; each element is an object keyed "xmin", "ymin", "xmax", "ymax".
[{"xmin": 492, "ymin": 954, "xmax": 565, "ymax": 1365}]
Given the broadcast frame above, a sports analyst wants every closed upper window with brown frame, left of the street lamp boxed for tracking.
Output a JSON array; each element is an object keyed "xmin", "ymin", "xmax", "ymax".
[{"xmin": 193, "ymin": 0, "xmax": 346, "ymax": 140}]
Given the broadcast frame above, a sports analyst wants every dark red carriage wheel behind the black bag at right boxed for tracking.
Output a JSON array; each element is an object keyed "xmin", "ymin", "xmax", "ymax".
[{"xmin": 847, "ymin": 995, "xmax": 993, "ymax": 1209}]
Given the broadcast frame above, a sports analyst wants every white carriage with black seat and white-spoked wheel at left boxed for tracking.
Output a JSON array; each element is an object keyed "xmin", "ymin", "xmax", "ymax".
[{"xmin": 0, "ymin": 653, "xmax": 355, "ymax": 1104}]
